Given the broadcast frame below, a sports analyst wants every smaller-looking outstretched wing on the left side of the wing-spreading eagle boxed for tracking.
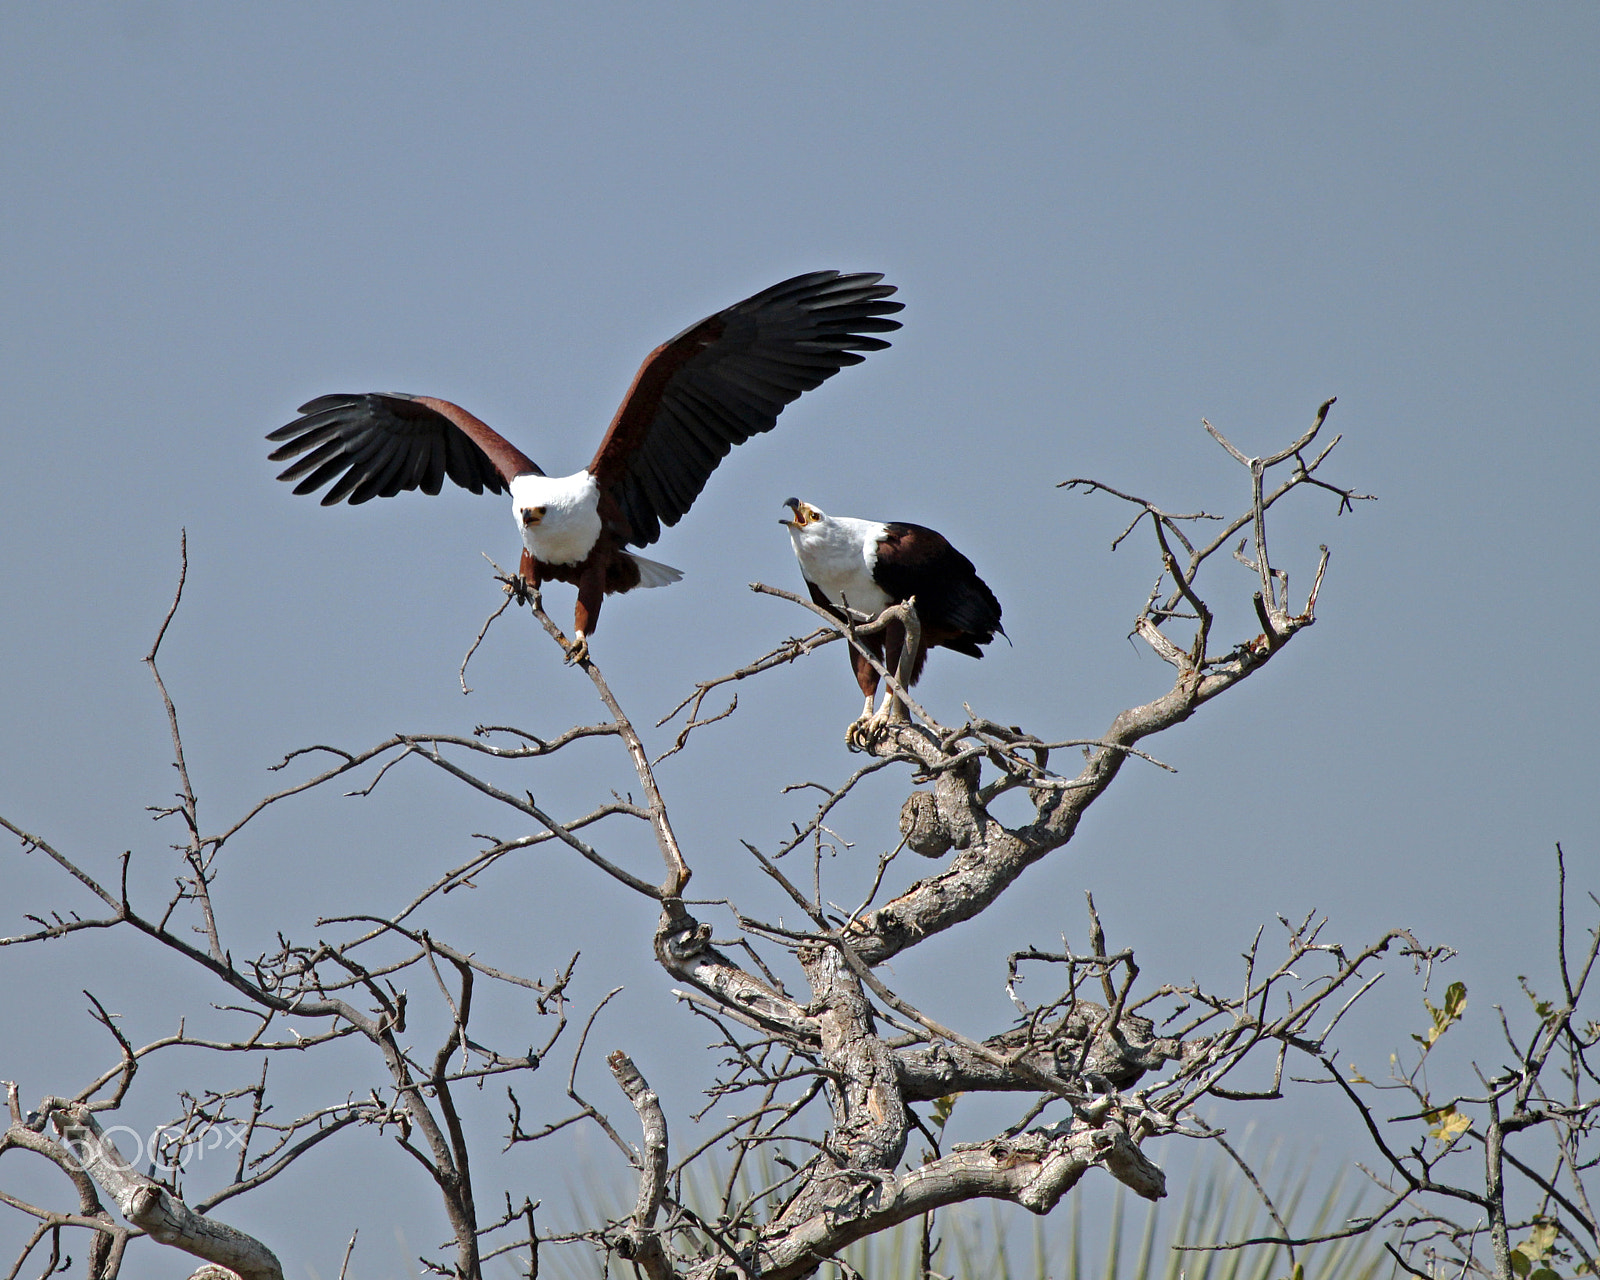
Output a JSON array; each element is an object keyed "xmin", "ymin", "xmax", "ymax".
[{"xmin": 267, "ymin": 392, "xmax": 544, "ymax": 507}]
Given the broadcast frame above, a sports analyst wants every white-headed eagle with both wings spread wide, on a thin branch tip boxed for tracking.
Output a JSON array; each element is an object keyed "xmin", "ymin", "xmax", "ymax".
[{"xmin": 267, "ymin": 270, "xmax": 904, "ymax": 662}]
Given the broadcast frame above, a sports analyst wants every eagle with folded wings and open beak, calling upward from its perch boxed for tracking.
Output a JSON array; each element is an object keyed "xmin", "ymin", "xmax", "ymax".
[{"xmin": 778, "ymin": 498, "xmax": 1010, "ymax": 746}]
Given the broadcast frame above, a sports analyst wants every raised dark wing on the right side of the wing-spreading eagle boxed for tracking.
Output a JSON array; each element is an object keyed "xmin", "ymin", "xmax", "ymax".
[{"xmin": 589, "ymin": 270, "xmax": 904, "ymax": 547}]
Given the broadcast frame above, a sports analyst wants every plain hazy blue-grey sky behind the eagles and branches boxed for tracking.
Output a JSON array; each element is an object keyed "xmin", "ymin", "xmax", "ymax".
[{"xmin": 0, "ymin": 0, "xmax": 1600, "ymax": 1277}]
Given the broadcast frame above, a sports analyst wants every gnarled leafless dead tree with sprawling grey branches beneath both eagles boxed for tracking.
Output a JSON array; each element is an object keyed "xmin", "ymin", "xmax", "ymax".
[{"xmin": 0, "ymin": 402, "xmax": 1440, "ymax": 1280}]
